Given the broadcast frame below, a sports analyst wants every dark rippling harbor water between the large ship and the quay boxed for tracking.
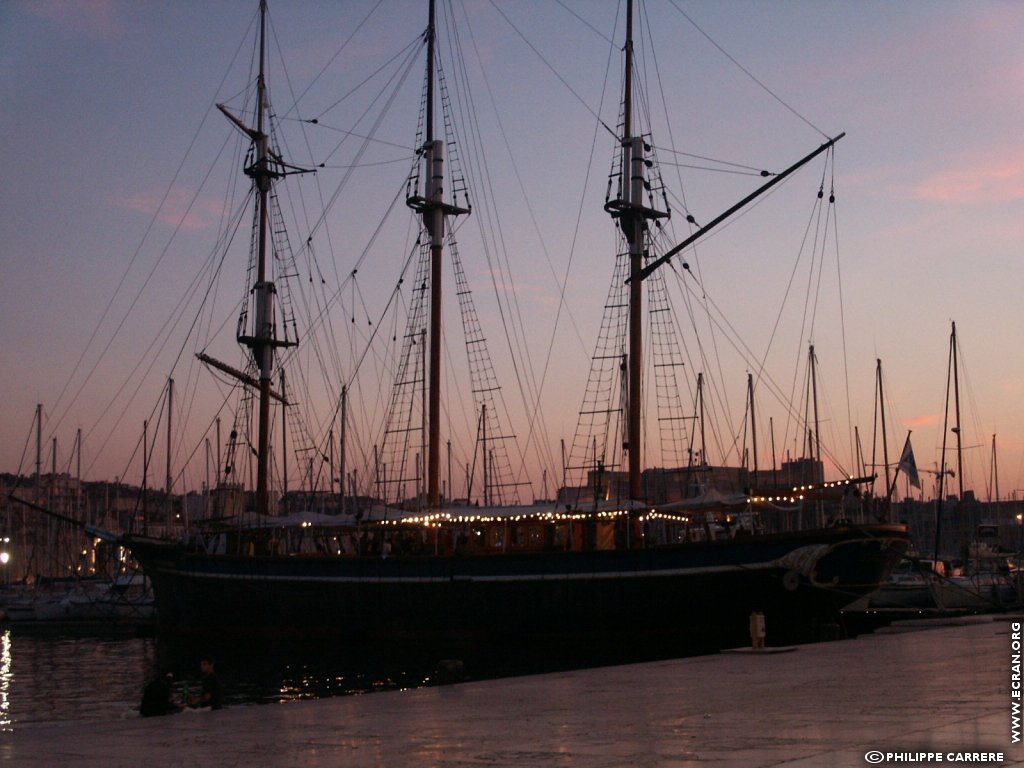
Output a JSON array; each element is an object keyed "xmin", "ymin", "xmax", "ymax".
[{"xmin": 0, "ymin": 626, "xmax": 683, "ymax": 731}]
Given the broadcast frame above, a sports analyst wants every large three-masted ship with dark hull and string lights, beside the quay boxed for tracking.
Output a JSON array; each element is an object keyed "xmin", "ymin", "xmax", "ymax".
[{"xmin": 22, "ymin": 3, "xmax": 907, "ymax": 650}]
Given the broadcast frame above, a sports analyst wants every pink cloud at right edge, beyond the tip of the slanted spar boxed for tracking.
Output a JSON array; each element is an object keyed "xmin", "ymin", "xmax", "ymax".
[{"xmin": 913, "ymin": 152, "xmax": 1024, "ymax": 205}]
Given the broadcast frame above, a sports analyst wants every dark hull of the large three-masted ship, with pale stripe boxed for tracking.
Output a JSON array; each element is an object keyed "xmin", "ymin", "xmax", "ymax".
[{"xmin": 123, "ymin": 524, "xmax": 908, "ymax": 650}]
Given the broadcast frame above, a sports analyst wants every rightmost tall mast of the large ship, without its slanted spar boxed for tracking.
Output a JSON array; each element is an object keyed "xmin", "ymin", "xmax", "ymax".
[{"xmin": 604, "ymin": 0, "xmax": 668, "ymax": 499}]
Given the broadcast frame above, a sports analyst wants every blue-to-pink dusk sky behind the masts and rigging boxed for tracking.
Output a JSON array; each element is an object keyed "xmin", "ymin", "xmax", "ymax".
[{"xmin": 0, "ymin": 0, "xmax": 1024, "ymax": 499}]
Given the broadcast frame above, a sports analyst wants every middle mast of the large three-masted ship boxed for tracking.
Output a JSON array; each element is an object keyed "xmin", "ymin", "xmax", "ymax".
[{"xmin": 406, "ymin": 0, "xmax": 469, "ymax": 518}]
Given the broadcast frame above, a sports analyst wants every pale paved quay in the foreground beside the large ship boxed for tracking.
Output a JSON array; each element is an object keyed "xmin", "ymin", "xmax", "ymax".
[{"xmin": 0, "ymin": 616, "xmax": 1024, "ymax": 768}]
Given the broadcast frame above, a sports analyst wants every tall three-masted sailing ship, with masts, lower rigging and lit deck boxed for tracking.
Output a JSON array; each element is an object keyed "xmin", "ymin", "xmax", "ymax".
[{"xmin": 24, "ymin": 0, "xmax": 908, "ymax": 650}]
